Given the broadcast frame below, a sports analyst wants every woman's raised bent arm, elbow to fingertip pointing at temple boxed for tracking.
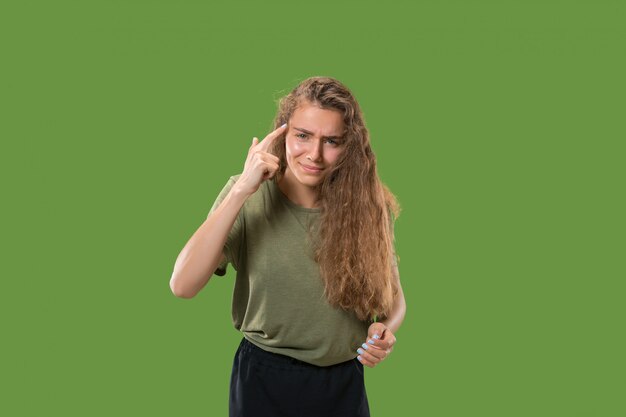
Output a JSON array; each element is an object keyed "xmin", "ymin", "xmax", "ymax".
[{"xmin": 170, "ymin": 124, "xmax": 286, "ymax": 298}]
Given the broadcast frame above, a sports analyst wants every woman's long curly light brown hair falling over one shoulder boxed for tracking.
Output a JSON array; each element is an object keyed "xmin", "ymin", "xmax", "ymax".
[{"xmin": 270, "ymin": 77, "xmax": 400, "ymax": 321}]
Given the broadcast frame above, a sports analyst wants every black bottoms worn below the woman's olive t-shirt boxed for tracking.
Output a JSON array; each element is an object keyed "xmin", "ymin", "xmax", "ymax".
[{"xmin": 229, "ymin": 337, "xmax": 370, "ymax": 417}]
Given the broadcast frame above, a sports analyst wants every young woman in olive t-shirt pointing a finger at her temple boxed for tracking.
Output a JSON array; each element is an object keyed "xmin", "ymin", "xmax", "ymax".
[{"xmin": 170, "ymin": 77, "xmax": 406, "ymax": 417}]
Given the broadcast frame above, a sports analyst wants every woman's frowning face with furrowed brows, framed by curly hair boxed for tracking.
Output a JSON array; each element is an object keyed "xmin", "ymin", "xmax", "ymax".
[{"xmin": 285, "ymin": 101, "xmax": 345, "ymax": 187}]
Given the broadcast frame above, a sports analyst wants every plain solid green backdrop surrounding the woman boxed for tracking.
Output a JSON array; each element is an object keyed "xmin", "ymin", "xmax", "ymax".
[{"xmin": 0, "ymin": 0, "xmax": 626, "ymax": 417}]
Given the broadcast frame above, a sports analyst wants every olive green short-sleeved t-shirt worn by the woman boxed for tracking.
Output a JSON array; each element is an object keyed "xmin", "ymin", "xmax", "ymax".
[{"xmin": 209, "ymin": 175, "xmax": 371, "ymax": 366}]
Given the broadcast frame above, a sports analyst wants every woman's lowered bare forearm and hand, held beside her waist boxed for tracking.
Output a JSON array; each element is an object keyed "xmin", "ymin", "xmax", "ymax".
[{"xmin": 357, "ymin": 266, "xmax": 406, "ymax": 368}]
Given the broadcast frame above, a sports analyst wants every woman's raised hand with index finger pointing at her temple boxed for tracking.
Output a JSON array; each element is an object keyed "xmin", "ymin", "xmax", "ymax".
[{"xmin": 236, "ymin": 123, "xmax": 287, "ymax": 196}]
